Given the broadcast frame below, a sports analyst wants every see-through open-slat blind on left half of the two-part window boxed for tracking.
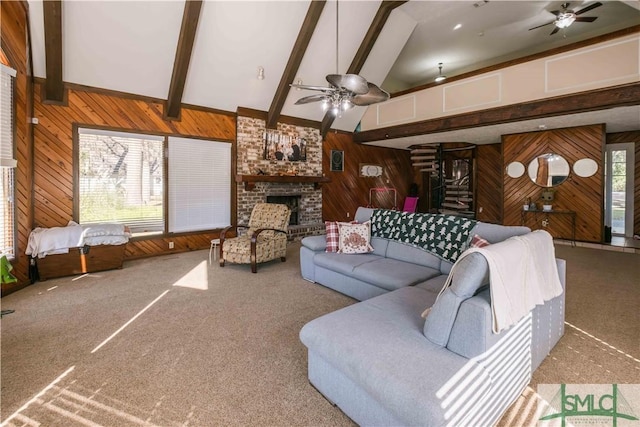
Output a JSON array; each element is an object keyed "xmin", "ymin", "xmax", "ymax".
[{"xmin": 77, "ymin": 128, "xmax": 164, "ymax": 235}]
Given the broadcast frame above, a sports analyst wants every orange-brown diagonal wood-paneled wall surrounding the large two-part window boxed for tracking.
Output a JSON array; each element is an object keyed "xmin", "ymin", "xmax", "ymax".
[{"xmin": 33, "ymin": 84, "xmax": 236, "ymax": 259}]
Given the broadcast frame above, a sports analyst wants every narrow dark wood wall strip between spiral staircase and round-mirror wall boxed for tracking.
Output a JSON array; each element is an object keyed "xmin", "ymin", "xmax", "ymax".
[{"xmin": 474, "ymin": 144, "xmax": 504, "ymax": 224}]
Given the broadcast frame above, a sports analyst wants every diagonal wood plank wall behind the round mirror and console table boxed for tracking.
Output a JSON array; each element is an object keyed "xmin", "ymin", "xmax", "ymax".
[{"xmin": 502, "ymin": 124, "xmax": 605, "ymax": 242}]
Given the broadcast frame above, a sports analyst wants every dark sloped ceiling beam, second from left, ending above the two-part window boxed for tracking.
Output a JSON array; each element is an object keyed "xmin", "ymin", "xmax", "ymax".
[{"xmin": 164, "ymin": 0, "xmax": 202, "ymax": 120}]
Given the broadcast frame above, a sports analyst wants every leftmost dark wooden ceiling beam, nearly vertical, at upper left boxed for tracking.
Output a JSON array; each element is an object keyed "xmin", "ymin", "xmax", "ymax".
[{"xmin": 42, "ymin": 0, "xmax": 64, "ymax": 104}]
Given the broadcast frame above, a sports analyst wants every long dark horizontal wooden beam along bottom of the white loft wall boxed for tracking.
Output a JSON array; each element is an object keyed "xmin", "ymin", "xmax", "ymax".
[{"xmin": 353, "ymin": 83, "xmax": 640, "ymax": 143}]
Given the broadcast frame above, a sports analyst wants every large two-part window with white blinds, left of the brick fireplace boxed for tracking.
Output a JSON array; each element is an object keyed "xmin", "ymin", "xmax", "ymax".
[{"xmin": 77, "ymin": 128, "xmax": 231, "ymax": 235}]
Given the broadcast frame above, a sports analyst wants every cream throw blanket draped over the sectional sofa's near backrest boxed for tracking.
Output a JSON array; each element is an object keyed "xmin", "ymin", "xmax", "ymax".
[{"xmin": 447, "ymin": 230, "xmax": 562, "ymax": 333}]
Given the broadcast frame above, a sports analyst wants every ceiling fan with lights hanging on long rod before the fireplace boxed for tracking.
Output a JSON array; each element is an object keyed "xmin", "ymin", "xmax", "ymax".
[{"xmin": 290, "ymin": 0, "xmax": 389, "ymax": 116}]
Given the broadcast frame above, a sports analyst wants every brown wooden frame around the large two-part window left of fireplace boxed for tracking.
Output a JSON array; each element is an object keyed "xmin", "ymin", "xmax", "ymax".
[{"xmin": 72, "ymin": 123, "xmax": 236, "ymax": 242}]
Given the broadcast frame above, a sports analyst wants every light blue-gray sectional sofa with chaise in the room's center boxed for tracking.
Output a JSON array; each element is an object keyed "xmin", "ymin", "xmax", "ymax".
[{"xmin": 300, "ymin": 208, "xmax": 565, "ymax": 426}]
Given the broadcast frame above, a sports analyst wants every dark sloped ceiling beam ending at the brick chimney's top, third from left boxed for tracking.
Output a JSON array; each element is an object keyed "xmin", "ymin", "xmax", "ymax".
[{"xmin": 267, "ymin": 0, "xmax": 326, "ymax": 129}]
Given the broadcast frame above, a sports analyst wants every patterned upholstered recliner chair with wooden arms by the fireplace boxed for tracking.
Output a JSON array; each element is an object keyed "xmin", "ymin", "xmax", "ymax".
[{"xmin": 220, "ymin": 203, "xmax": 291, "ymax": 273}]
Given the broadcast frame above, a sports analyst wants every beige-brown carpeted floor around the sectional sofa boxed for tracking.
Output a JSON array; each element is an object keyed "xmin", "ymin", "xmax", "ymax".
[{"xmin": 0, "ymin": 244, "xmax": 640, "ymax": 426}]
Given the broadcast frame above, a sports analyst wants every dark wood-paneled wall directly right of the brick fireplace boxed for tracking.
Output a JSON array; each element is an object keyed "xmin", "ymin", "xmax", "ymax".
[{"xmin": 322, "ymin": 131, "xmax": 414, "ymax": 221}]
